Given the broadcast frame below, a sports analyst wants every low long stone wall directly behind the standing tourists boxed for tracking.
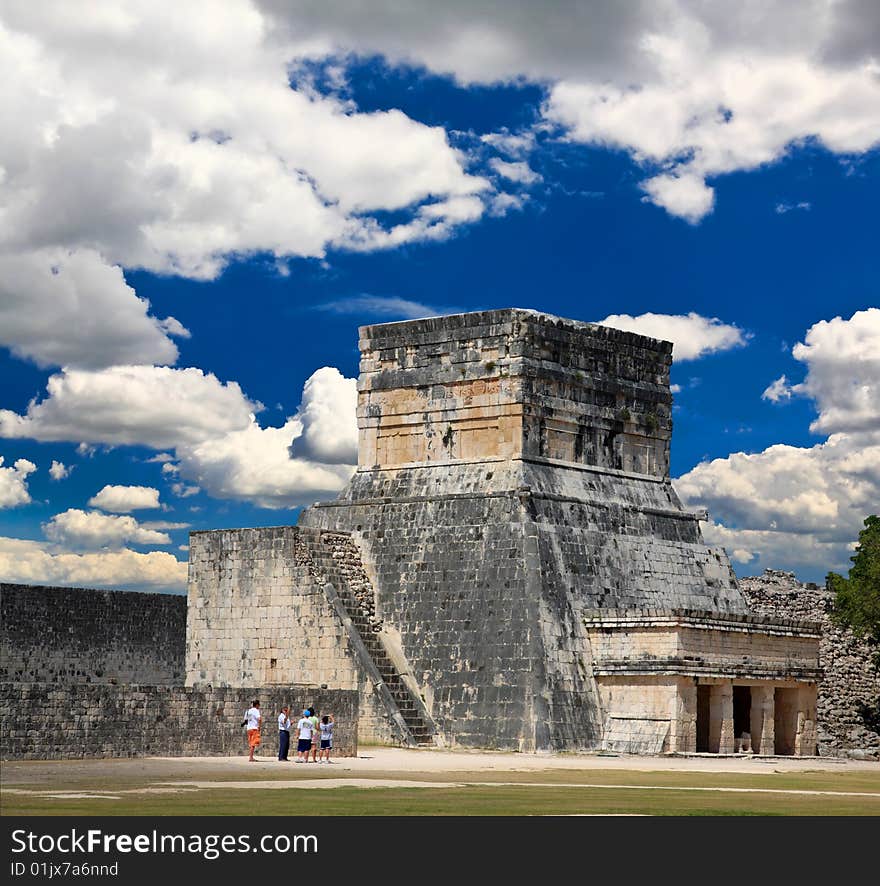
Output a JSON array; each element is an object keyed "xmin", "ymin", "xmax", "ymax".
[{"xmin": 0, "ymin": 683, "xmax": 358, "ymax": 760}]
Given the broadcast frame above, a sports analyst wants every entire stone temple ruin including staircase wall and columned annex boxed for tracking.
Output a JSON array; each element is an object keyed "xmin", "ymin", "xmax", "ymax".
[{"xmin": 186, "ymin": 309, "xmax": 821, "ymax": 755}]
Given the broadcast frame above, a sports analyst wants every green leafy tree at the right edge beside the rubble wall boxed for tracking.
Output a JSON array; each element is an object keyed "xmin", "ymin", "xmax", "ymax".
[{"xmin": 825, "ymin": 516, "xmax": 880, "ymax": 648}]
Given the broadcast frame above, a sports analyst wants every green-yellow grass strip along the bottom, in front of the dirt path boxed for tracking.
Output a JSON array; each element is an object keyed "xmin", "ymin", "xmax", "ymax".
[{"xmin": 0, "ymin": 765, "xmax": 880, "ymax": 816}]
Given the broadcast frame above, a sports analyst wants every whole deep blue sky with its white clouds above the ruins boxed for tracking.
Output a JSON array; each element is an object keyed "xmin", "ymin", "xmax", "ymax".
[{"xmin": 0, "ymin": 2, "xmax": 880, "ymax": 590}]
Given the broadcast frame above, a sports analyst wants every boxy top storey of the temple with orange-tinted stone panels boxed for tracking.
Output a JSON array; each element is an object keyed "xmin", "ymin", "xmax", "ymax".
[{"xmin": 358, "ymin": 309, "xmax": 672, "ymax": 476}]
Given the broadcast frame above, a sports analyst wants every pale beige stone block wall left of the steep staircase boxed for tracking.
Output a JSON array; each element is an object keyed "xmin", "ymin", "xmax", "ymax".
[{"xmin": 186, "ymin": 526, "xmax": 392, "ymax": 744}]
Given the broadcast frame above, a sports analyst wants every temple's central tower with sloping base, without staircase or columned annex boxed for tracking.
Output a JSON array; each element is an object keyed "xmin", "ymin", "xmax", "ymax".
[{"xmin": 299, "ymin": 309, "xmax": 768, "ymax": 751}]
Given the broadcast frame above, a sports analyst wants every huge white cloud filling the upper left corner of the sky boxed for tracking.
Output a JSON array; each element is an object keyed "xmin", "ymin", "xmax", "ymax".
[{"xmin": 0, "ymin": 0, "xmax": 487, "ymax": 279}]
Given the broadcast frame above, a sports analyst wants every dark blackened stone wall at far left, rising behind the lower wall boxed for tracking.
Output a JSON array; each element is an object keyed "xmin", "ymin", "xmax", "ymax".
[{"xmin": 0, "ymin": 583, "xmax": 186, "ymax": 684}]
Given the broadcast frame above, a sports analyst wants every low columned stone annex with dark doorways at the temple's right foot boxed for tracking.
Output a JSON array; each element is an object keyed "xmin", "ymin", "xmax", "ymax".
[{"xmin": 584, "ymin": 609, "xmax": 822, "ymax": 755}]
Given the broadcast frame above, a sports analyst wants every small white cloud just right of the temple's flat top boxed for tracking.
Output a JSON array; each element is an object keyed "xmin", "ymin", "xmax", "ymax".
[{"xmin": 597, "ymin": 311, "xmax": 748, "ymax": 360}]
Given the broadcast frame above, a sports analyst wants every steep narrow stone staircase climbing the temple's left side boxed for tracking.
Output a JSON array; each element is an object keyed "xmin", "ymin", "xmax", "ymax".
[{"xmin": 309, "ymin": 530, "xmax": 436, "ymax": 746}]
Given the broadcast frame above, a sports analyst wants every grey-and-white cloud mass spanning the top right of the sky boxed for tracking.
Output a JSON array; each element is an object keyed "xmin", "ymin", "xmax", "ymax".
[{"xmin": 254, "ymin": 0, "xmax": 880, "ymax": 222}]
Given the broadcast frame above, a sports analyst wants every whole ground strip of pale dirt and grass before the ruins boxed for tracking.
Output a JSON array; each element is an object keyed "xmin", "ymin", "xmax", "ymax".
[{"xmin": 0, "ymin": 747, "xmax": 880, "ymax": 817}]
